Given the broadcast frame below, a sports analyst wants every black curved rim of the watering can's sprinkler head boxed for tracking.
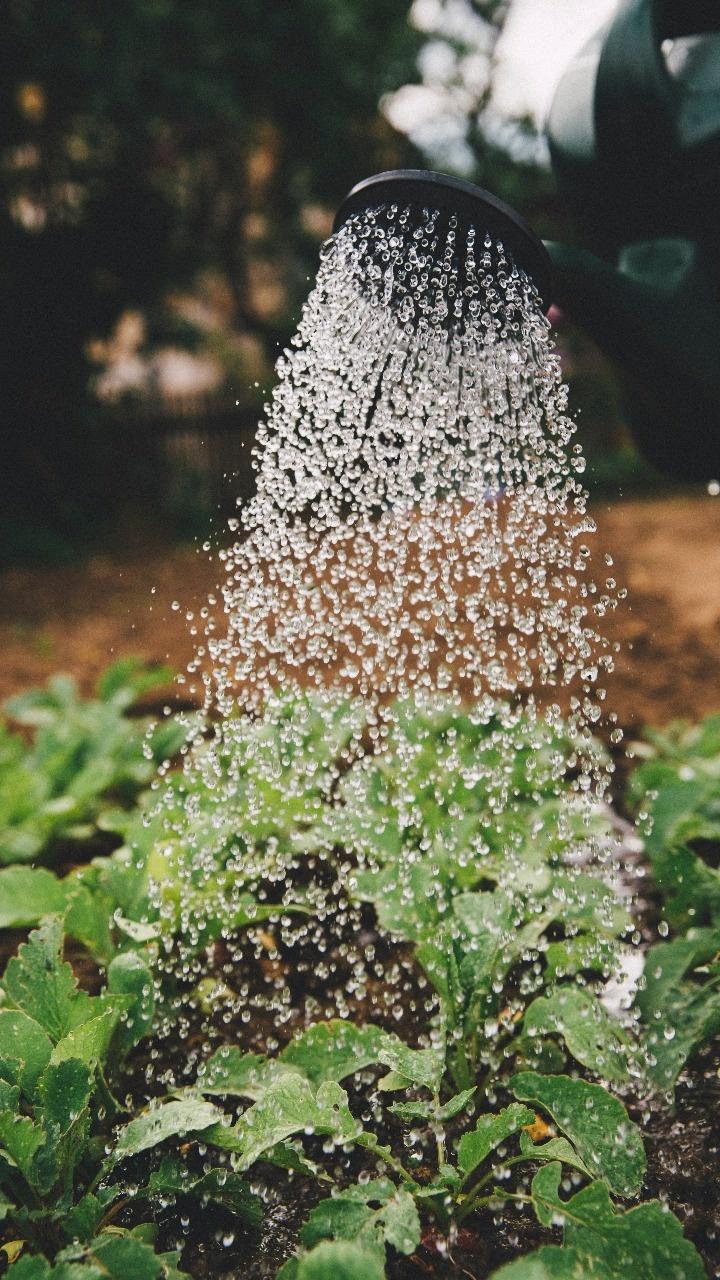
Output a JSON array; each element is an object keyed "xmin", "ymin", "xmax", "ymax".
[{"xmin": 333, "ymin": 169, "xmax": 552, "ymax": 311}]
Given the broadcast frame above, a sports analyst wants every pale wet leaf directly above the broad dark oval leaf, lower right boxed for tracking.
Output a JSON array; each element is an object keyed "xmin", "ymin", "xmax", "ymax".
[{"xmin": 523, "ymin": 986, "xmax": 630, "ymax": 1084}]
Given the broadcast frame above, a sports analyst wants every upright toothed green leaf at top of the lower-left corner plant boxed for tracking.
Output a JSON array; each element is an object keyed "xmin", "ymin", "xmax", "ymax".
[{"xmin": 4, "ymin": 920, "xmax": 92, "ymax": 1041}]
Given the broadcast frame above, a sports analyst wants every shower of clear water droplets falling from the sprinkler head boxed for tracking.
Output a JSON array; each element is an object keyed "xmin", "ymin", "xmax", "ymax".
[{"xmin": 149, "ymin": 199, "xmax": 621, "ymax": 1044}]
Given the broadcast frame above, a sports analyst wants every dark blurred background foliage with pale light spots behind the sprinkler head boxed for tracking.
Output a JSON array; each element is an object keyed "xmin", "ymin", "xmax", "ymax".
[{"xmin": 0, "ymin": 0, "xmax": 638, "ymax": 562}]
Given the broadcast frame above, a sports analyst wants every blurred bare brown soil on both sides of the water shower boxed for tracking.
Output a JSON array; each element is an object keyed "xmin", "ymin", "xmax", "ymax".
[{"xmin": 0, "ymin": 495, "xmax": 720, "ymax": 731}]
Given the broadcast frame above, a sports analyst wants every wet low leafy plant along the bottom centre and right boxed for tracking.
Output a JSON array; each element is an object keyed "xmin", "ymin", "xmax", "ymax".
[{"xmin": 178, "ymin": 1020, "xmax": 703, "ymax": 1280}]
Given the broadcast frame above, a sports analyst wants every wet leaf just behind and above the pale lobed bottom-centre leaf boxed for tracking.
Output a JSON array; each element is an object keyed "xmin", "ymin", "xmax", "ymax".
[{"xmin": 281, "ymin": 1018, "xmax": 391, "ymax": 1085}]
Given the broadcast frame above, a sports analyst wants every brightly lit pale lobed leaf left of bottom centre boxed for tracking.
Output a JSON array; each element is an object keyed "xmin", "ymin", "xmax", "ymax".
[{"xmin": 224, "ymin": 1075, "xmax": 360, "ymax": 1169}]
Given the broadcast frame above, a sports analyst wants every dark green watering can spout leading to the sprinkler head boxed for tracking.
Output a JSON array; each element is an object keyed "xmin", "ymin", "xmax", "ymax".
[{"xmin": 546, "ymin": 238, "xmax": 720, "ymax": 480}]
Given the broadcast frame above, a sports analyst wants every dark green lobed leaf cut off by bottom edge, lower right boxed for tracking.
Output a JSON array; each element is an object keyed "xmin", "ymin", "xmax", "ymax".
[{"xmin": 520, "ymin": 1164, "xmax": 705, "ymax": 1280}]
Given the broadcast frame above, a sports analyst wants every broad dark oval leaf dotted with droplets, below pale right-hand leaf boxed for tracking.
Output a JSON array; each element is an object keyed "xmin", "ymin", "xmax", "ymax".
[{"xmin": 510, "ymin": 1071, "xmax": 646, "ymax": 1196}]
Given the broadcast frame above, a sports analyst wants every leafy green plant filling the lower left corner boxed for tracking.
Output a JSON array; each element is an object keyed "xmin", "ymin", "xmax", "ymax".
[{"xmin": 0, "ymin": 920, "xmax": 259, "ymax": 1280}]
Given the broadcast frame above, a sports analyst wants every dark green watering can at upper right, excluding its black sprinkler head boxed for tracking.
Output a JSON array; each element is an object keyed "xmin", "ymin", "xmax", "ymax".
[{"xmin": 547, "ymin": 0, "xmax": 720, "ymax": 480}]
